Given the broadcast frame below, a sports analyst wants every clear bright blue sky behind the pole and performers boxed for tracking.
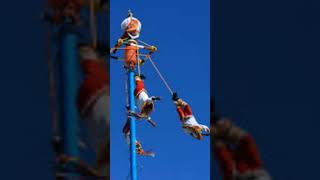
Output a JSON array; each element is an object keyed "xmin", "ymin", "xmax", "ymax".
[{"xmin": 110, "ymin": 0, "xmax": 210, "ymax": 180}]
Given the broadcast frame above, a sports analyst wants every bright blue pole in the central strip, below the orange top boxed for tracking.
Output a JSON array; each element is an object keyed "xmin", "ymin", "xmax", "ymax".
[{"xmin": 128, "ymin": 69, "xmax": 137, "ymax": 180}]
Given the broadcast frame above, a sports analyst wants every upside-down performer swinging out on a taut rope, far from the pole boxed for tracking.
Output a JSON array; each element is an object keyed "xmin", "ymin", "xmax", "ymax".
[{"xmin": 172, "ymin": 93, "xmax": 210, "ymax": 140}]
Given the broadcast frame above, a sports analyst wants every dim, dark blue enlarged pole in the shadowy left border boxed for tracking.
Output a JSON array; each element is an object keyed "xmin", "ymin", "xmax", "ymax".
[{"xmin": 60, "ymin": 25, "xmax": 79, "ymax": 157}]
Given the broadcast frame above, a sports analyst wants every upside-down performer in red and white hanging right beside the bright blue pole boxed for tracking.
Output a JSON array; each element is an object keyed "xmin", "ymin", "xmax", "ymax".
[{"xmin": 134, "ymin": 75, "xmax": 160, "ymax": 125}]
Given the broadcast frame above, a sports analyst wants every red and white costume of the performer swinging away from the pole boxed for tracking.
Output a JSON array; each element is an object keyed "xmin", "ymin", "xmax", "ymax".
[{"xmin": 176, "ymin": 102, "xmax": 210, "ymax": 137}]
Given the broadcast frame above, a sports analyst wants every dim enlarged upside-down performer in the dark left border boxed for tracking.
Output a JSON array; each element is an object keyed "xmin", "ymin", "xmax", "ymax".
[{"xmin": 77, "ymin": 45, "xmax": 110, "ymax": 176}]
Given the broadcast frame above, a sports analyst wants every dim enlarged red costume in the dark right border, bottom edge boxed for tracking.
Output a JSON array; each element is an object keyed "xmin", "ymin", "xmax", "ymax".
[{"xmin": 215, "ymin": 134, "xmax": 271, "ymax": 180}]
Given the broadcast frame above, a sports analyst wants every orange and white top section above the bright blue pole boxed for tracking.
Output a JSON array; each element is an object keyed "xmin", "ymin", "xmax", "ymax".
[{"xmin": 110, "ymin": 11, "xmax": 157, "ymax": 69}]
